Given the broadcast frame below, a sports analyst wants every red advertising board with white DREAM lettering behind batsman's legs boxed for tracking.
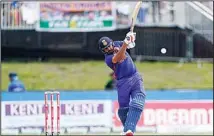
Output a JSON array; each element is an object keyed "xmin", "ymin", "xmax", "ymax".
[{"xmin": 113, "ymin": 100, "xmax": 213, "ymax": 127}]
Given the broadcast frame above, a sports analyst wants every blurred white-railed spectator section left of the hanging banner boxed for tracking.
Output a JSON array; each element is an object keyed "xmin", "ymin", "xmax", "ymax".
[{"xmin": 1, "ymin": 2, "xmax": 37, "ymax": 30}]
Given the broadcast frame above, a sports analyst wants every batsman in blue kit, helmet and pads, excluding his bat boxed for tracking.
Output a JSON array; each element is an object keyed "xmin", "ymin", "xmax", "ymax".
[{"xmin": 98, "ymin": 32, "xmax": 146, "ymax": 136}]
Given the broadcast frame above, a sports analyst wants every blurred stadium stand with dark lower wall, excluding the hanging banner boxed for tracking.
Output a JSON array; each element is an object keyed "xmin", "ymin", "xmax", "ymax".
[{"xmin": 1, "ymin": 1, "xmax": 213, "ymax": 60}]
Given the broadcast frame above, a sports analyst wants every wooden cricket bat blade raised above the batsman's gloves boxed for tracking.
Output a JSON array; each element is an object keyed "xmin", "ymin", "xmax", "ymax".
[{"xmin": 130, "ymin": 1, "xmax": 142, "ymax": 32}]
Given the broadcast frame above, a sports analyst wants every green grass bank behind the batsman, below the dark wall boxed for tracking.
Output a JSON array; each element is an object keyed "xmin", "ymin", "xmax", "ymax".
[{"xmin": 1, "ymin": 61, "xmax": 213, "ymax": 90}]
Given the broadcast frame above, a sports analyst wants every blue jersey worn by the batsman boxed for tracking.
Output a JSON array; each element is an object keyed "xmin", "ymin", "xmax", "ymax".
[{"xmin": 105, "ymin": 41, "xmax": 137, "ymax": 80}]
